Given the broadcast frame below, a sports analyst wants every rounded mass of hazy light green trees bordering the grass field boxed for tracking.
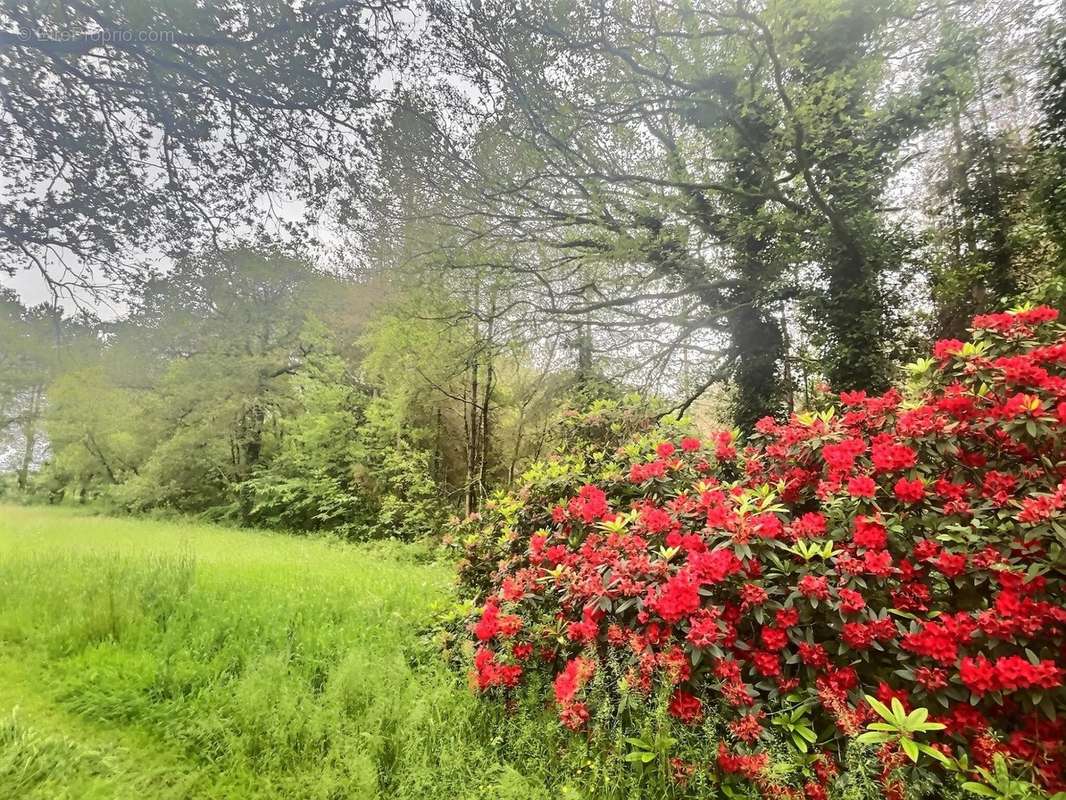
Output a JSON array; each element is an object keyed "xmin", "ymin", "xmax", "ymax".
[{"xmin": 33, "ymin": 251, "xmax": 445, "ymax": 539}]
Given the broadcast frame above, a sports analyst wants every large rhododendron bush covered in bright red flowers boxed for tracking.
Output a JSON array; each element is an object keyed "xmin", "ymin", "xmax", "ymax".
[{"xmin": 462, "ymin": 307, "xmax": 1066, "ymax": 800}]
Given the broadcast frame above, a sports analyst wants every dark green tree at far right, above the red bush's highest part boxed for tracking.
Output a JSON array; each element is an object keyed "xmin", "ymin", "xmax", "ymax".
[{"xmin": 925, "ymin": 2, "xmax": 1059, "ymax": 338}]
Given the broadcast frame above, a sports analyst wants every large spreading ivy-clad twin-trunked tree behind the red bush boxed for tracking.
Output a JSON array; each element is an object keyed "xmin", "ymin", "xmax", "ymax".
[{"xmin": 413, "ymin": 1, "xmax": 966, "ymax": 426}]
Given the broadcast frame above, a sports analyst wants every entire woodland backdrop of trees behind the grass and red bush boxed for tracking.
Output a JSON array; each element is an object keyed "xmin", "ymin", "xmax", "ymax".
[{"xmin": 0, "ymin": 0, "xmax": 1066, "ymax": 538}]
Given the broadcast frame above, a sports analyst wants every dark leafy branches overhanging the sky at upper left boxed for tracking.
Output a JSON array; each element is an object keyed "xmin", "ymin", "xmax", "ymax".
[{"xmin": 0, "ymin": 0, "xmax": 400, "ymax": 291}]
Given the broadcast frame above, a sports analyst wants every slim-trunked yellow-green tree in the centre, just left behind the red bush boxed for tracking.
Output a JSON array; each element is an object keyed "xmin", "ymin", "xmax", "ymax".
[{"xmin": 362, "ymin": 270, "xmax": 576, "ymax": 513}]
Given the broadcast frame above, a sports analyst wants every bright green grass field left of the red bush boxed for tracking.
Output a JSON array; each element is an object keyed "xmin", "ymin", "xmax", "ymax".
[{"xmin": 0, "ymin": 506, "xmax": 588, "ymax": 800}]
